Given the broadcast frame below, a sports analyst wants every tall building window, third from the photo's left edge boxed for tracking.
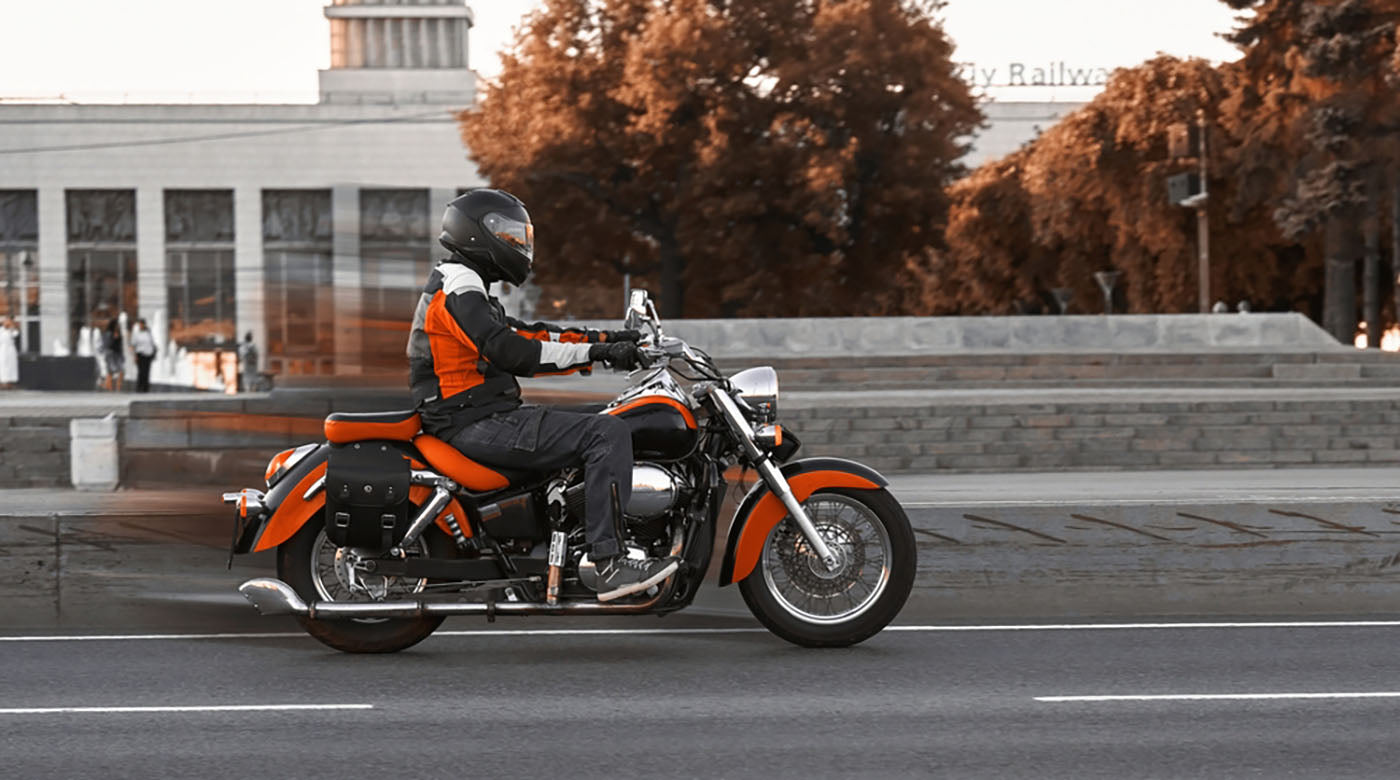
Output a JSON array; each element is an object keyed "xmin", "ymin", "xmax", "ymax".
[{"xmin": 165, "ymin": 189, "xmax": 237, "ymax": 347}]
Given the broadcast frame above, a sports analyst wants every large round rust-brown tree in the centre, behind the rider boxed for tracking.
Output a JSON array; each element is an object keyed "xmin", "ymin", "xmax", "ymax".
[{"xmin": 461, "ymin": 0, "xmax": 981, "ymax": 316}]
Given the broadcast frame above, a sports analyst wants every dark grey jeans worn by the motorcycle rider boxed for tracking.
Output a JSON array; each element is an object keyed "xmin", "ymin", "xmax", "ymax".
[{"xmin": 448, "ymin": 406, "xmax": 631, "ymax": 559}]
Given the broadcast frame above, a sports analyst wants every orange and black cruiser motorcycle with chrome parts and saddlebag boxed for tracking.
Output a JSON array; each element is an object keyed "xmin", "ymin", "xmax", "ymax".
[{"xmin": 223, "ymin": 290, "xmax": 917, "ymax": 653}]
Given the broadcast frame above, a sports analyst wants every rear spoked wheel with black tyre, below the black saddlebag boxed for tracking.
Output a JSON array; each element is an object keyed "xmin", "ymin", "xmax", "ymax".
[{"xmin": 277, "ymin": 514, "xmax": 456, "ymax": 653}]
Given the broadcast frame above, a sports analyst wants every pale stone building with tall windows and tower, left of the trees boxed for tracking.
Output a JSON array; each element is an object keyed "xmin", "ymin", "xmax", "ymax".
[{"xmin": 0, "ymin": 0, "xmax": 483, "ymax": 375}]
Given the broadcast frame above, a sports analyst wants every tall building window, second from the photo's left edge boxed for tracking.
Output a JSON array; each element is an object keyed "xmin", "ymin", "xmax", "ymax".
[{"xmin": 66, "ymin": 189, "xmax": 137, "ymax": 351}]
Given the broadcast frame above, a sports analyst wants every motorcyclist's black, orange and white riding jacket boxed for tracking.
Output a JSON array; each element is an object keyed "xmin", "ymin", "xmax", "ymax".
[{"xmin": 409, "ymin": 262, "xmax": 602, "ymax": 438}]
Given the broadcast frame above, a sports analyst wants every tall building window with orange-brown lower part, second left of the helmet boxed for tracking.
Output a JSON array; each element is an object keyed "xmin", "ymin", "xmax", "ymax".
[{"xmin": 263, "ymin": 189, "xmax": 335, "ymax": 374}]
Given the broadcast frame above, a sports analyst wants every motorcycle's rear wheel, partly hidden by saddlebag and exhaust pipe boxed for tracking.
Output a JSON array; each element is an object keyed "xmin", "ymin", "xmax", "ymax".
[{"xmin": 277, "ymin": 514, "xmax": 456, "ymax": 653}]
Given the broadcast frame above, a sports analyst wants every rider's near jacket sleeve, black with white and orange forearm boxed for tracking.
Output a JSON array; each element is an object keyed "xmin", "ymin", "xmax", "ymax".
[{"xmin": 447, "ymin": 287, "xmax": 591, "ymax": 377}]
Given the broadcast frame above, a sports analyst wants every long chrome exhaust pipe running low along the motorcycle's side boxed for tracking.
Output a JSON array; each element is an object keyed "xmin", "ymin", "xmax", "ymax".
[{"xmin": 238, "ymin": 576, "xmax": 676, "ymax": 620}]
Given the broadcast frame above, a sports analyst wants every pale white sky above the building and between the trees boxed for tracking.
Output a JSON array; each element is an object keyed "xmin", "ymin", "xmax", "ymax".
[{"xmin": 0, "ymin": 0, "xmax": 1238, "ymax": 102}]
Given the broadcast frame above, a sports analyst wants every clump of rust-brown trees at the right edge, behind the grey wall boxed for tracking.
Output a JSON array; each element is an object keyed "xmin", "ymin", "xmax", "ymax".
[{"xmin": 929, "ymin": 0, "xmax": 1400, "ymax": 334}]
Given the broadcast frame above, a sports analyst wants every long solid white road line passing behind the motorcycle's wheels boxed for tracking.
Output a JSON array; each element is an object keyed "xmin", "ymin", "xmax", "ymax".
[{"xmin": 8, "ymin": 620, "xmax": 1400, "ymax": 643}]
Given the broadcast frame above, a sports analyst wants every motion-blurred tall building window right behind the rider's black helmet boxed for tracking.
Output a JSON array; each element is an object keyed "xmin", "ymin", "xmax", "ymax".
[{"xmin": 360, "ymin": 189, "xmax": 433, "ymax": 372}]
